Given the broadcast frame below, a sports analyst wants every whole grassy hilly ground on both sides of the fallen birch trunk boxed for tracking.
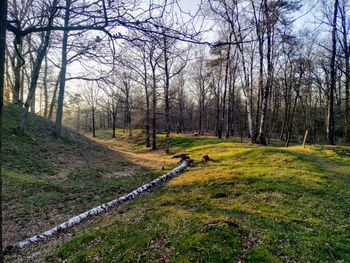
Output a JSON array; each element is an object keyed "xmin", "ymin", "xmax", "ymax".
[{"xmin": 4, "ymin": 106, "xmax": 350, "ymax": 262}]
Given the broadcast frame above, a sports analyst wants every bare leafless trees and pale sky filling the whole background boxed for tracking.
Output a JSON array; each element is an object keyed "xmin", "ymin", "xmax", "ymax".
[{"xmin": 5, "ymin": 0, "xmax": 350, "ymax": 153}]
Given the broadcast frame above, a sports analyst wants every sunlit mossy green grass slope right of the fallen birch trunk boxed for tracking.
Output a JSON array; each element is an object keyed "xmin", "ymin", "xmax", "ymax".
[{"xmin": 47, "ymin": 131, "xmax": 350, "ymax": 262}]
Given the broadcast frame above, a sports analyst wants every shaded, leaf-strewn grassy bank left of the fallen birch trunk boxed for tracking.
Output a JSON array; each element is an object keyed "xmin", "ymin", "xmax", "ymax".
[{"xmin": 3, "ymin": 105, "xmax": 164, "ymax": 251}]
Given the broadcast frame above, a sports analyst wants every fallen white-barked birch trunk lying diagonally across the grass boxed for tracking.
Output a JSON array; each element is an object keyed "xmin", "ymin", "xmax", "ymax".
[{"xmin": 4, "ymin": 160, "xmax": 190, "ymax": 254}]
